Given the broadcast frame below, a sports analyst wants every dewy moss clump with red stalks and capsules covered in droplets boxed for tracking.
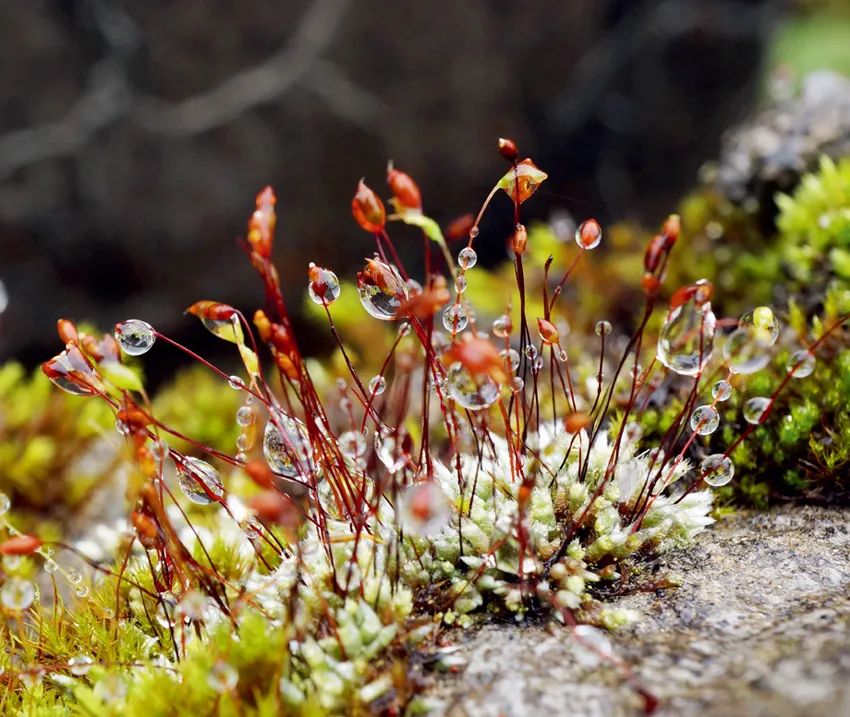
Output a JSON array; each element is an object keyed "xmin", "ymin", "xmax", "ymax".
[{"xmin": 0, "ymin": 140, "xmax": 843, "ymax": 716}]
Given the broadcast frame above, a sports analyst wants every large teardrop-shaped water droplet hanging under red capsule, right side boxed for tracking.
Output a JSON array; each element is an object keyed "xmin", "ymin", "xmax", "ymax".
[{"xmin": 658, "ymin": 297, "xmax": 717, "ymax": 376}]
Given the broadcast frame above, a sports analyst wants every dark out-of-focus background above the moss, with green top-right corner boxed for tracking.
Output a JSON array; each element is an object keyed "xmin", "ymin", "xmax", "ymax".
[{"xmin": 0, "ymin": 0, "xmax": 850, "ymax": 380}]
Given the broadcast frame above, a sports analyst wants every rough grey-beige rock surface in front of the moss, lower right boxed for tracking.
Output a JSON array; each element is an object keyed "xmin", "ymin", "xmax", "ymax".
[{"xmin": 432, "ymin": 507, "xmax": 850, "ymax": 717}]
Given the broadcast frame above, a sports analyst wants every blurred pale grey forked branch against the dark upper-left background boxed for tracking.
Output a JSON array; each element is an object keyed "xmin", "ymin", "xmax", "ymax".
[{"xmin": 0, "ymin": 0, "xmax": 354, "ymax": 181}]
